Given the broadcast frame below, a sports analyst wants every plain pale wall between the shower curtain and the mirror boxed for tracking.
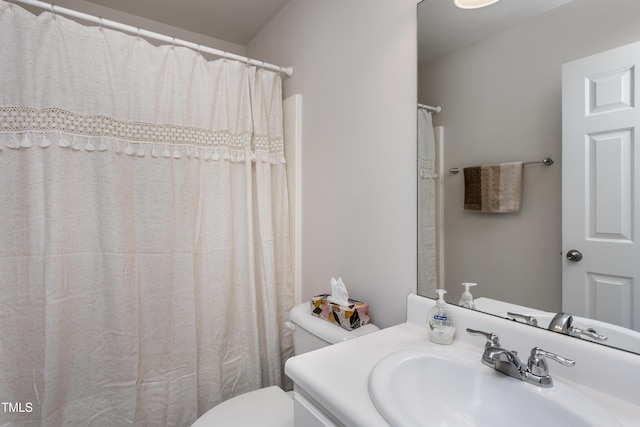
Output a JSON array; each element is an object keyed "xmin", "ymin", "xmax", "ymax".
[{"xmin": 247, "ymin": 0, "xmax": 417, "ymax": 327}]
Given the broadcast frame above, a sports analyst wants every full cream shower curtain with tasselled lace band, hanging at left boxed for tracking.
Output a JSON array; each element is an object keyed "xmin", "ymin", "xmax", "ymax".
[{"xmin": 0, "ymin": 2, "xmax": 294, "ymax": 426}]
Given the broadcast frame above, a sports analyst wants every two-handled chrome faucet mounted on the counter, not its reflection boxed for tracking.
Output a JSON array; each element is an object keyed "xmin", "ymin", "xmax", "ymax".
[{"xmin": 467, "ymin": 328, "xmax": 575, "ymax": 387}]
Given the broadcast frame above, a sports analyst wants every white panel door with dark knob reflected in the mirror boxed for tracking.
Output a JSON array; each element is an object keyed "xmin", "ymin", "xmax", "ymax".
[{"xmin": 562, "ymin": 43, "xmax": 640, "ymax": 330}]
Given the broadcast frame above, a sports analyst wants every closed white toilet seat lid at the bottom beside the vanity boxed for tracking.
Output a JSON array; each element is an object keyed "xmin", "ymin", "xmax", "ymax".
[{"xmin": 191, "ymin": 386, "xmax": 293, "ymax": 427}]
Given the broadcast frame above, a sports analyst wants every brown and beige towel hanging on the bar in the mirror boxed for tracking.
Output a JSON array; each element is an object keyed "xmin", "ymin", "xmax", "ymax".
[{"xmin": 464, "ymin": 162, "xmax": 524, "ymax": 213}]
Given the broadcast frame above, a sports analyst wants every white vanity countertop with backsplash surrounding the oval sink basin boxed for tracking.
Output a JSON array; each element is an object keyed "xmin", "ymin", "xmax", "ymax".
[{"xmin": 285, "ymin": 296, "xmax": 640, "ymax": 427}]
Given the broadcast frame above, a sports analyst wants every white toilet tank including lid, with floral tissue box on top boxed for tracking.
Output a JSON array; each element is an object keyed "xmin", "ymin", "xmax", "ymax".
[{"xmin": 289, "ymin": 301, "xmax": 379, "ymax": 354}]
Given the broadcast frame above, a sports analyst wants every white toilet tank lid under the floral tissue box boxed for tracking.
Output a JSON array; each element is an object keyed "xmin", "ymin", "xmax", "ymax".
[{"xmin": 289, "ymin": 301, "xmax": 380, "ymax": 344}]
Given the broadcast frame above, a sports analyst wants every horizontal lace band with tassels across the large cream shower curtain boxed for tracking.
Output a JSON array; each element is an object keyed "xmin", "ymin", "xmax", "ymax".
[{"xmin": 0, "ymin": 107, "xmax": 285, "ymax": 164}]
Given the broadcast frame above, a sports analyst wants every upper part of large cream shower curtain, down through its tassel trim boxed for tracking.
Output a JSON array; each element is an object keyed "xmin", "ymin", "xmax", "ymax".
[{"xmin": 0, "ymin": 1, "xmax": 285, "ymax": 164}]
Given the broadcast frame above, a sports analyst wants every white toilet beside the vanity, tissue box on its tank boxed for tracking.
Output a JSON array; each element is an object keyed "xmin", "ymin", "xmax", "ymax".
[{"xmin": 191, "ymin": 301, "xmax": 378, "ymax": 427}]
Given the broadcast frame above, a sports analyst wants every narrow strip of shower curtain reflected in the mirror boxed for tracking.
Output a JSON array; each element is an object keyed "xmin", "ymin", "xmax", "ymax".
[{"xmin": 418, "ymin": 108, "xmax": 438, "ymax": 296}]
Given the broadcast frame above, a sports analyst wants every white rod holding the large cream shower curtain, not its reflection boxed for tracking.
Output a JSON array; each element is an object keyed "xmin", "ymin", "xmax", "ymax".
[{"xmin": 9, "ymin": 0, "xmax": 293, "ymax": 77}]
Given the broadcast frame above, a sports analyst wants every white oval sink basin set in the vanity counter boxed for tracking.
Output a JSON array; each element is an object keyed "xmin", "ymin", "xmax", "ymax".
[{"xmin": 369, "ymin": 347, "xmax": 620, "ymax": 427}]
